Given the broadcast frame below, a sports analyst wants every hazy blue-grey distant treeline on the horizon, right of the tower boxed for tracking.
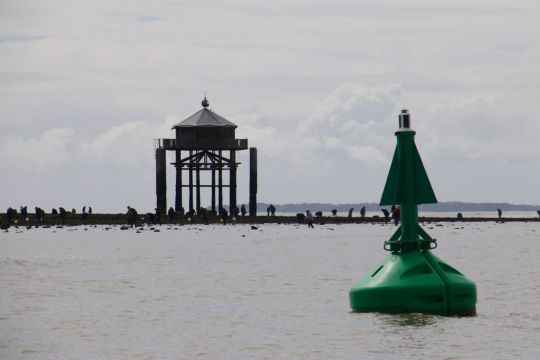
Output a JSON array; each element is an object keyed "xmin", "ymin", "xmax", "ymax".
[{"xmin": 257, "ymin": 201, "xmax": 540, "ymax": 213}]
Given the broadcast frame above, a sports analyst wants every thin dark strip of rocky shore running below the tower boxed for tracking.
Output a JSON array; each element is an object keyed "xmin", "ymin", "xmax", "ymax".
[{"xmin": 0, "ymin": 213, "xmax": 540, "ymax": 229}]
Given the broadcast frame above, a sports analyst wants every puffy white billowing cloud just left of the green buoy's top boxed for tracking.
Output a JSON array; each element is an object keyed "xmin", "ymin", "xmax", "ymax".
[{"xmin": 297, "ymin": 83, "xmax": 403, "ymax": 167}]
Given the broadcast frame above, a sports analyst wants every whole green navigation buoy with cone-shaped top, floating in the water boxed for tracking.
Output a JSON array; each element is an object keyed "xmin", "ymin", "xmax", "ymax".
[{"xmin": 349, "ymin": 110, "xmax": 476, "ymax": 316}]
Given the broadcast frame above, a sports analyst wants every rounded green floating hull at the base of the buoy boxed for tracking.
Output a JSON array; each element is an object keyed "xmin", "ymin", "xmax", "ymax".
[{"xmin": 349, "ymin": 251, "xmax": 476, "ymax": 316}]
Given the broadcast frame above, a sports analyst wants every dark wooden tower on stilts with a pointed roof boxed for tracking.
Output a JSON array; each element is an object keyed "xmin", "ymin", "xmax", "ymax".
[{"xmin": 155, "ymin": 97, "xmax": 257, "ymax": 216}]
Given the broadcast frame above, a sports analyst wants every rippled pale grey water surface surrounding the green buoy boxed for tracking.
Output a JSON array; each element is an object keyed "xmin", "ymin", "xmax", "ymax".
[{"xmin": 0, "ymin": 222, "xmax": 540, "ymax": 359}]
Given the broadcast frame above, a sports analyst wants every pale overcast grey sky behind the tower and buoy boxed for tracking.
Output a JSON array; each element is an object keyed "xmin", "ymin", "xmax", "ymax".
[{"xmin": 0, "ymin": 0, "xmax": 540, "ymax": 212}]
